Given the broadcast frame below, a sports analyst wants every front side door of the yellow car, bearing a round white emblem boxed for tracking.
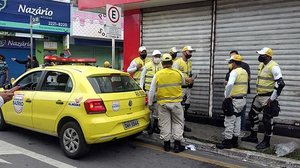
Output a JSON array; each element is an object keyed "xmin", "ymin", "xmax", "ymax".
[{"xmin": 2, "ymin": 71, "xmax": 42, "ymax": 128}]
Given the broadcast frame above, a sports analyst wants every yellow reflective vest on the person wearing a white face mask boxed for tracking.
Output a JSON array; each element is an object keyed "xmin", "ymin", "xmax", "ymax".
[{"xmin": 144, "ymin": 61, "xmax": 163, "ymax": 91}]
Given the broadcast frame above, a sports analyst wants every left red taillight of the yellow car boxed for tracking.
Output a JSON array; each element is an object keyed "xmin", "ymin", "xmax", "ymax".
[{"xmin": 84, "ymin": 99, "xmax": 106, "ymax": 114}]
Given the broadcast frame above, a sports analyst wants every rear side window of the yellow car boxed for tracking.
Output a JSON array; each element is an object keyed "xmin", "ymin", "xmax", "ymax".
[{"xmin": 41, "ymin": 71, "xmax": 73, "ymax": 92}]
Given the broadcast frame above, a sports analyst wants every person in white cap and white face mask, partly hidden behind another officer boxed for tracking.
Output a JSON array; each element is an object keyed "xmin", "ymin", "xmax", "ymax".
[{"xmin": 140, "ymin": 50, "xmax": 162, "ymax": 134}]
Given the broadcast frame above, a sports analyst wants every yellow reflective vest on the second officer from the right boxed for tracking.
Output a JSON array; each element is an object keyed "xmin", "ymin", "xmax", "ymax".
[{"xmin": 230, "ymin": 67, "xmax": 248, "ymax": 97}]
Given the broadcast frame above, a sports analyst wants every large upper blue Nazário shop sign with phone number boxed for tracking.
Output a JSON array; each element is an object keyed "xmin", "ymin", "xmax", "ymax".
[{"xmin": 0, "ymin": 0, "xmax": 70, "ymax": 34}]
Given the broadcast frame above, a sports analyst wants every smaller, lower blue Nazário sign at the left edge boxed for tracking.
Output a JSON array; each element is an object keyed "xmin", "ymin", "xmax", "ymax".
[{"xmin": 0, "ymin": 37, "xmax": 30, "ymax": 49}]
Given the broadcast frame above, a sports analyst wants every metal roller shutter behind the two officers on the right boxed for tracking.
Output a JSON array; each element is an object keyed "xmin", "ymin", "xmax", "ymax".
[{"xmin": 213, "ymin": 0, "xmax": 300, "ymax": 124}]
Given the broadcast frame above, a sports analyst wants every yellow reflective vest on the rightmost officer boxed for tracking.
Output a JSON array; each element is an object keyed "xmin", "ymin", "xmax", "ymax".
[{"xmin": 256, "ymin": 60, "xmax": 278, "ymax": 94}]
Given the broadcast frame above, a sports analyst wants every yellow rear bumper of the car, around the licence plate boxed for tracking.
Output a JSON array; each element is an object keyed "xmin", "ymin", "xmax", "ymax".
[{"xmin": 81, "ymin": 110, "xmax": 150, "ymax": 144}]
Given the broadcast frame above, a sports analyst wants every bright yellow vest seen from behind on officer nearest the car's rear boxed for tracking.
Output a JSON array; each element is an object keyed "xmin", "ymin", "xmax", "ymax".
[{"xmin": 155, "ymin": 68, "xmax": 182, "ymax": 104}]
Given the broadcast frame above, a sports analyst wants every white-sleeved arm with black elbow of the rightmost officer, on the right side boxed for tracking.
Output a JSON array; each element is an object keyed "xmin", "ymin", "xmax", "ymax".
[{"xmin": 270, "ymin": 66, "xmax": 285, "ymax": 101}]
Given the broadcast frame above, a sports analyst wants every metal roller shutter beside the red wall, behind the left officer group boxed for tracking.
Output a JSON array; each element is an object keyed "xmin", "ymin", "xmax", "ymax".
[{"xmin": 142, "ymin": 1, "xmax": 212, "ymax": 116}]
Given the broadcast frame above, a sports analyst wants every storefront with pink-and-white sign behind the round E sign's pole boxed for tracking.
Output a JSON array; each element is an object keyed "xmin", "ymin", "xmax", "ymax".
[{"xmin": 70, "ymin": 7, "xmax": 123, "ymax": 70}]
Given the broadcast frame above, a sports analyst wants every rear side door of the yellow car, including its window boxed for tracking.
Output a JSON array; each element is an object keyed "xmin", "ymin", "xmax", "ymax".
[{"xmin": 32, "ymin": 71, "xmax": 73, "ymax": 133}]
